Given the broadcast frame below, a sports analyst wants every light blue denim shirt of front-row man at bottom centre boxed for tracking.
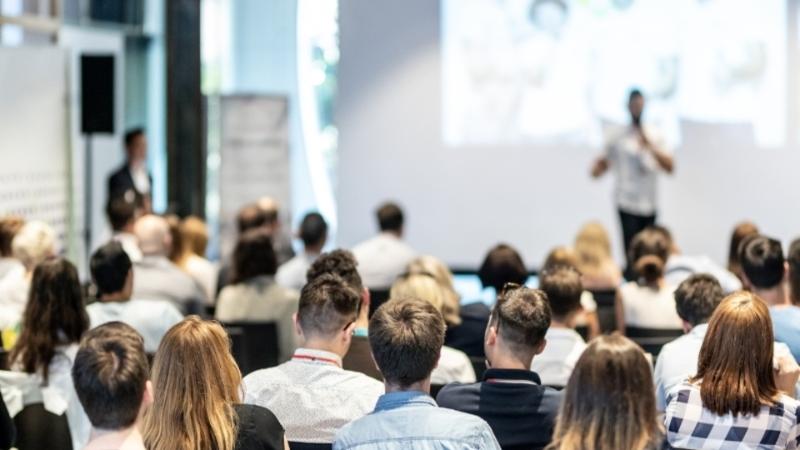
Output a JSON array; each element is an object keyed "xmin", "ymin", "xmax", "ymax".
[{"xmin": 333, "ymin": 391, "xmax": 500, "ymax": 450}]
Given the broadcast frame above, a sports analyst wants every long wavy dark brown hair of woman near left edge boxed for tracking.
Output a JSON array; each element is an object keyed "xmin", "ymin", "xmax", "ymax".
[{"xmin": 9, "ymin": 258, "xmax": 89, "ymax": 383}]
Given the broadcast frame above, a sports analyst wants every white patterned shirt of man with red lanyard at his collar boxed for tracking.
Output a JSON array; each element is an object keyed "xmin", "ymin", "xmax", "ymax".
[{"xmin": 242, "ymin": 348, "xmax": 385, "ymax": 444}]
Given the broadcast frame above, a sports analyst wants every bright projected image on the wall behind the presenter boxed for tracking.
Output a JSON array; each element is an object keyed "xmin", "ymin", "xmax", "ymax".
[{"xmin": 442, "ymin": 0, "xmax": 787, "ymax": 147}]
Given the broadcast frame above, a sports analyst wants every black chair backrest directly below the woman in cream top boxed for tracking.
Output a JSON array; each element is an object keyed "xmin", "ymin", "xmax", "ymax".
[{"xmin": 223, "ymin": 322, "xmax": 278, "ymax": 376}]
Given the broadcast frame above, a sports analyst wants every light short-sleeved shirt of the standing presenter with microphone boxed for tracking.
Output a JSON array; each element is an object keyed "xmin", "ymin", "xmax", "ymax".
[{"xmin": 606, "ymin": 125, "xmax": 669, "ymax": 216}]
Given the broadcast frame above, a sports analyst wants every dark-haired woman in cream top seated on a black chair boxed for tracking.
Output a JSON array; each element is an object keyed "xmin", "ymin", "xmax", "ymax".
[{"xmin": 215, "ymin": 229, "xmax": 298, "ymax": 362}]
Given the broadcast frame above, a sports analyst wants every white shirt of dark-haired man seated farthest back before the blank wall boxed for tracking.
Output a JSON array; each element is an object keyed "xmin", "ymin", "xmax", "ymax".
[{"xmin": 353, "ymin": 233, "xmax": 417, "ymax": 289}]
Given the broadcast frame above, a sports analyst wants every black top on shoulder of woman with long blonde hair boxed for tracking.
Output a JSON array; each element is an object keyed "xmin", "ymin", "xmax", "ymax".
[{"xmin": 233, "ymin": 405, "xmax": 284, "ymax": 450}]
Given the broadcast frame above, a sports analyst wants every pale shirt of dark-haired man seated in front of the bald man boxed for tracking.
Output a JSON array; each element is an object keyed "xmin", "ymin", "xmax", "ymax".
[{"xmin": 86, "ymin": 300, "xmax": 183, "ymax": 353}]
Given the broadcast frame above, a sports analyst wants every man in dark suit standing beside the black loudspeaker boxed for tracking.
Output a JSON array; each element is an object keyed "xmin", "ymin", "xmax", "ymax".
[{"xmin": 108, "ymin": 128, "xmax": 153, "ymax": 211}]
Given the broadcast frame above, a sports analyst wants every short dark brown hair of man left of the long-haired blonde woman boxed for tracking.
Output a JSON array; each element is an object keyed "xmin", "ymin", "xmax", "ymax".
[{"xmin": 72, "ymin": 322, "xmax": 150, "ymax": 430}]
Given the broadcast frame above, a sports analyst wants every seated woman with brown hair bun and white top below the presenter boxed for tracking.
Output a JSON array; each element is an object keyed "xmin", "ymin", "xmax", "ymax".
[{"xmin": 616, "ymin": 227, "xmax": 682, "ymax": 332}]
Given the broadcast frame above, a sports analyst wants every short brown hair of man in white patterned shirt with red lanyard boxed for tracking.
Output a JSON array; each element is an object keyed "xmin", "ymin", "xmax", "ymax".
[{"xmin": 297, "ymin": 274, "xmax": 361, "ymax": 337}]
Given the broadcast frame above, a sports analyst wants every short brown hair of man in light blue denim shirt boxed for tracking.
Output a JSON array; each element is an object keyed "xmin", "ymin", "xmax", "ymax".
[{"xmin": 369, "ymin": 299, "xmax": 445, "ymax": 387}]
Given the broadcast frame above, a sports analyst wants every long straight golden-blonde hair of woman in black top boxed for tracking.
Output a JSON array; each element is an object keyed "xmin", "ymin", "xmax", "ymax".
[{"xmin": 143, "ymin": 316, "xmax": 242, "ymax": 450}]
